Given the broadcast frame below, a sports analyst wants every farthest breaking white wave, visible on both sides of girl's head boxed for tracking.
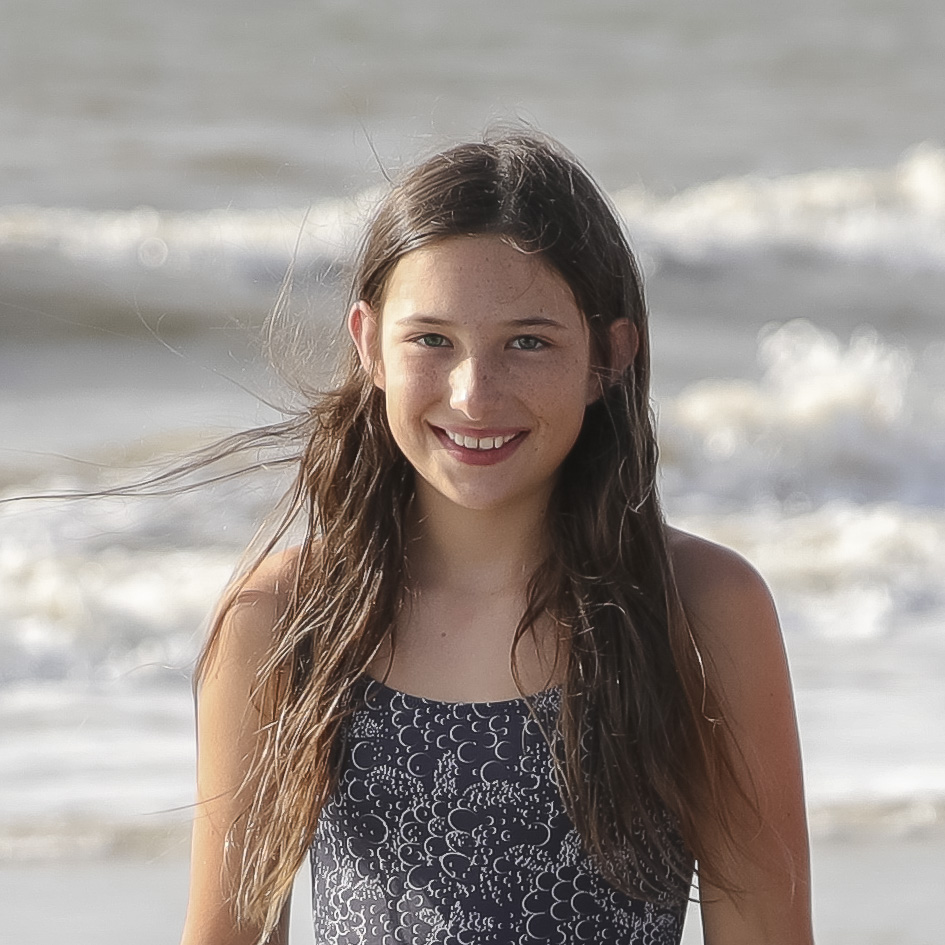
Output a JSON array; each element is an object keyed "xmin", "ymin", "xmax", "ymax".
[{"xmin": 0, "ymin": 143, "xmax": 945, "ymax": 324}]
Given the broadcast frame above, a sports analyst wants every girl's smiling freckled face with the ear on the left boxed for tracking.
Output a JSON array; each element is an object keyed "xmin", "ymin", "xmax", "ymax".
[{"xmin": 349, "ymin": 236, "xmax": 599, "ymax": 510}]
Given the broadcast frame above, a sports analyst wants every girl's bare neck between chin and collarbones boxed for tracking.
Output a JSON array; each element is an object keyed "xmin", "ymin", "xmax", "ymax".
[{"xmin": 407, "ymin": 483, "xmax": 547, "ymax": 594}]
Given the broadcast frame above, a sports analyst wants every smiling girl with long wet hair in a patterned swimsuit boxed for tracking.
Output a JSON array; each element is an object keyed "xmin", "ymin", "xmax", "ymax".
[{"xmin": 177, "ymin": 133, "xmax": 811, "ymax": 945}]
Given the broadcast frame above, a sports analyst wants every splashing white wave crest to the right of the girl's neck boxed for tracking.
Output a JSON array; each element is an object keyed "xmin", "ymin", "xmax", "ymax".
[{"xmin": 660, "ymin": 321, "xmax": 945, "ymax": 506}]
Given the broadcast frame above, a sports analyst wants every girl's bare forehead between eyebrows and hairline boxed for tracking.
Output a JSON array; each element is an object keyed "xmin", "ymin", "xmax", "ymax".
[{"xmin": 382, "ymin": 236, "xmax": 583, "ymax": 323}]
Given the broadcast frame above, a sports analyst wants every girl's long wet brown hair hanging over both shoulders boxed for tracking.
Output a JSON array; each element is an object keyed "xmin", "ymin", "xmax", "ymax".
[{"xmin": 210, "ymin": 132, "xmax": 756, "ymax": 932}]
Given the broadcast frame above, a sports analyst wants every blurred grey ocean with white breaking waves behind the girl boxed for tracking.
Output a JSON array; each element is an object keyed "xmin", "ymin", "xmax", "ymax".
[{"xmin": 0, "ymin": 0, "xmax": 945, "ymax": 920}]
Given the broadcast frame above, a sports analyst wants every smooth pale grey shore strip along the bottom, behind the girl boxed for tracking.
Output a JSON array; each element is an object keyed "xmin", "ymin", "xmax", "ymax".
[{"xmin": 0, "ymin": 829, "xmax": 945, "ymax": 945}]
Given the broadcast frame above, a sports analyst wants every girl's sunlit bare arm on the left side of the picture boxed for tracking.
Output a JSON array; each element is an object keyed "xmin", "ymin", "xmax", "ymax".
[{"xmin": 181, "ymin": 553, "xmax": 293, "ymax": 945}]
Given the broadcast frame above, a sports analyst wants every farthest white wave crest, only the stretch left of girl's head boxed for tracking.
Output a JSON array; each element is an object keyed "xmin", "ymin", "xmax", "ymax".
[{"xmin": 0, "ymin": 194, "xmax": 369, "ymax": 334}]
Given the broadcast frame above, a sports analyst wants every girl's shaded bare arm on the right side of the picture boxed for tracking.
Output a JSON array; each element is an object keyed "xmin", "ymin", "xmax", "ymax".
[{"xmin": 671, "ymin": 532, "xmax": 812, "ymax": 945}]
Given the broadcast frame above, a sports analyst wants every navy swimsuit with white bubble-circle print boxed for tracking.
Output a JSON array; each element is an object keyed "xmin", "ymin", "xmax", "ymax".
[{"xmin": 312, "ymin": 680, "xmax": 689, "ymax": 945}]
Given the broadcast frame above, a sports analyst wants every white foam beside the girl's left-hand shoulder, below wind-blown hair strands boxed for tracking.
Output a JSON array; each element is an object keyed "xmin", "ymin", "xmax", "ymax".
[{"xmin": 0, "ymin": 488, "xmax": 260, "ymax": 682}]
